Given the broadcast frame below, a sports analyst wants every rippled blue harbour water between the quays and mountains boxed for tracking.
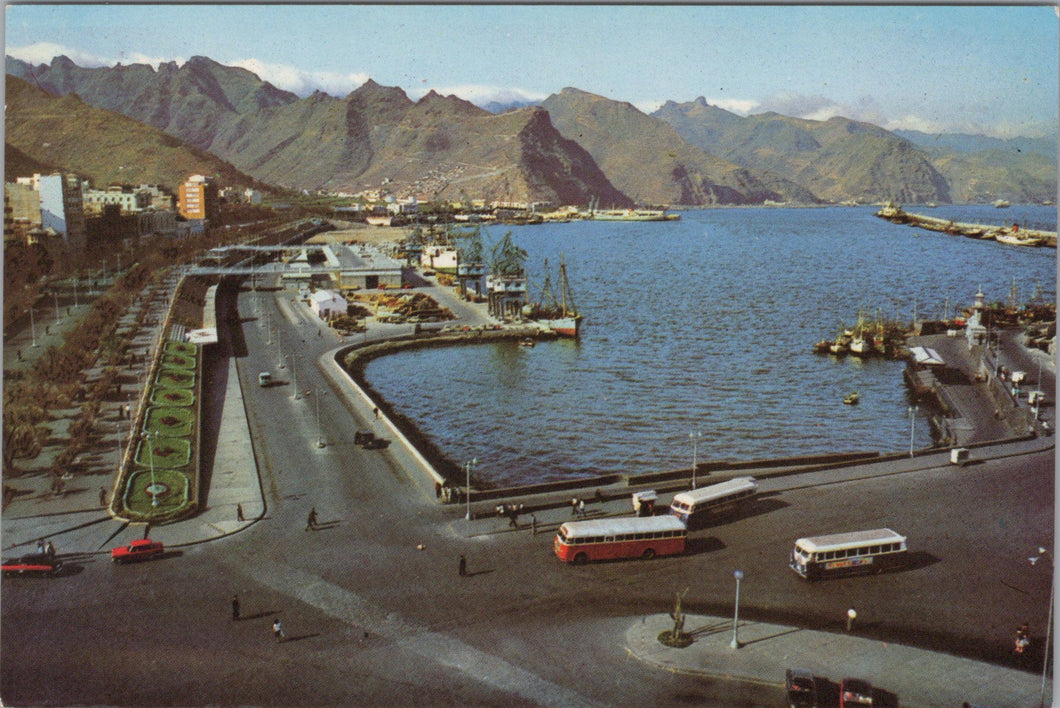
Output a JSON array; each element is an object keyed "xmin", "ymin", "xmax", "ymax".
[{"xmin": 366, "ymin": 207, "xmax": 1057, "ymax": 484}]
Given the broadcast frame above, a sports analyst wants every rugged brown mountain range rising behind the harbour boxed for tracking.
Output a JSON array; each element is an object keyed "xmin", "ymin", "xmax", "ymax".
[{"xmin": 5, "ymin": 56, "xmax": 1057, "ymax": 207}]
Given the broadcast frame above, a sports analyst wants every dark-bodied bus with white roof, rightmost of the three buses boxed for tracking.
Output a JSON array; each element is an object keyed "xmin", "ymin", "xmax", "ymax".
[{"xmin": 789, "ymin": 529, "xmax": 907, "ymax": 580}]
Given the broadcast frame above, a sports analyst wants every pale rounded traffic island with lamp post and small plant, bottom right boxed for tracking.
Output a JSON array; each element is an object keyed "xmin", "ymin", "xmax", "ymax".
[{"xmin": 625, "ymin": 615, "xmax": 1053, "ymax": 708}]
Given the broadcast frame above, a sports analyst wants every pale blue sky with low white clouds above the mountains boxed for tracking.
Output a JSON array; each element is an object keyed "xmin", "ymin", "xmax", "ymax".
[{"xmin": 4, "ymin": 3, "xmax": 1060, "ymax": 137}]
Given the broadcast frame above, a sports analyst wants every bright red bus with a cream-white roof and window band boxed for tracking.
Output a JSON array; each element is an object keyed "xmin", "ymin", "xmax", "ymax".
[{"xmin": 552, "ymin": 516, "xmax": 688, "ymax": 565}]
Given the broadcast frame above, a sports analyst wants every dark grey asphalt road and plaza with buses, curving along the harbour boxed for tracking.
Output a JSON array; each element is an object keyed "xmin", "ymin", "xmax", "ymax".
[{"xmin": 0, "ymin": 277, "xmax": 1054, "ymax": 706}]
